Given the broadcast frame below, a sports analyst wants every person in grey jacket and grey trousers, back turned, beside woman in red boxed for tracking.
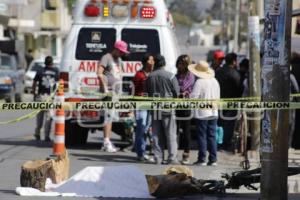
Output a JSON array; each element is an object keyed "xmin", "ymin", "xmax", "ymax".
[{"xmin": 145, "ymin": 55, "xmax": 179, "ymax": 164}]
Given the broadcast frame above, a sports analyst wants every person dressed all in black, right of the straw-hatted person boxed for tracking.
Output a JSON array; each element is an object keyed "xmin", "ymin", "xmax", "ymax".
[{"xmin": 216, "ymin": 53, "xmax": 242, "ymax": 151}]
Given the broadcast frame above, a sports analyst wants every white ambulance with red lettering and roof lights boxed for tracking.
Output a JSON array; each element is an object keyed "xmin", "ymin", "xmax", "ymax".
[{"xmin": 60, "ymin": 0, "xmax": 179, "ymax": 145}]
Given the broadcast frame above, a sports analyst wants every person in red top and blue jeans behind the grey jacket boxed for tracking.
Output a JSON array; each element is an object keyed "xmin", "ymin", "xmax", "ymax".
[{"xmin": 133, "ymin": 54, "xmax": 154, "ymax": 161}]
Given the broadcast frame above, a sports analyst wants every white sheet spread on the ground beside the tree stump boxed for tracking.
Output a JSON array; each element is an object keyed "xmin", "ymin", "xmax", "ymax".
[{"xmin": 16, "ymin": 166, "xmax": 153, "ymax": 198}]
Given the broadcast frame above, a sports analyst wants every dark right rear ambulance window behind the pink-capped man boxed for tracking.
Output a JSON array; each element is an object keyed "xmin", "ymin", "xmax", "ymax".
[{"xmin": 122, "ymin": 29, "xmax": 160, "ymax": 61}]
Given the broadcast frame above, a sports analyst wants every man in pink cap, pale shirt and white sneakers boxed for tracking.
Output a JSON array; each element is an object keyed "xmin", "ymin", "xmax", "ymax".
[{"xmin": 97, "ymin": 40, "xmax": 129, "ymax": 153}]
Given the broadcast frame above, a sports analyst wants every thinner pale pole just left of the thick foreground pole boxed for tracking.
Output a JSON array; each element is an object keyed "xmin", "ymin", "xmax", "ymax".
[{"xmin": 248, "ymin": 0, "xmax": 261, "ymax": 150}]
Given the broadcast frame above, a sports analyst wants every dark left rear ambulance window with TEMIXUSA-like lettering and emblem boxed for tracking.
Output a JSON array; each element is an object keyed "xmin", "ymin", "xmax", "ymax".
[{"xmin": 76, "ymin": 28, "xmax": 116, "ymax": 60}]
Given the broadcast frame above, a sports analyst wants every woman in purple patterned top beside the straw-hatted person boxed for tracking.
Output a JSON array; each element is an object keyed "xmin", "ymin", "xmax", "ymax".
[{"xmin": 176, "ymin": 55, "xmax": 196, "ymax": 165}]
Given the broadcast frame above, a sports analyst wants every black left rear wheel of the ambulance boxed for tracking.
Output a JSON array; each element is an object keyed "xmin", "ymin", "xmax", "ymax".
[{"xmin": 65, "ymin": 121, "xmax": 89, "ymax": 147}]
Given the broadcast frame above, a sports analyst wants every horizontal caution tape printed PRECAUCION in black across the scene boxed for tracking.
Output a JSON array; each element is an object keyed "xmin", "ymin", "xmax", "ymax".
[{"xmin": 0, "ymin": 100, "xmax": 300, "ymax": 112}]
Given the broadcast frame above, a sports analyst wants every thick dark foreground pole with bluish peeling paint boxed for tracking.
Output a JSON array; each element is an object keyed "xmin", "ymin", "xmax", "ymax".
[{"xmin": 261, "ymin": 0, "xmax": 292, "ymax": 200}]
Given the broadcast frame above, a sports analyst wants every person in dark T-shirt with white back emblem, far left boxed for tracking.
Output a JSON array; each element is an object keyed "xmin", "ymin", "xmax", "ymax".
[{"xmin": 32, "ymin": 56, "xmax": 59, "ymax": 142}]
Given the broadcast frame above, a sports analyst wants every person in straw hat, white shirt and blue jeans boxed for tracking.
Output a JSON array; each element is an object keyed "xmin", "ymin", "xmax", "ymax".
[{"xmin": 188, "ymin": 61, "xmax": 220, "ymax": 166}]
